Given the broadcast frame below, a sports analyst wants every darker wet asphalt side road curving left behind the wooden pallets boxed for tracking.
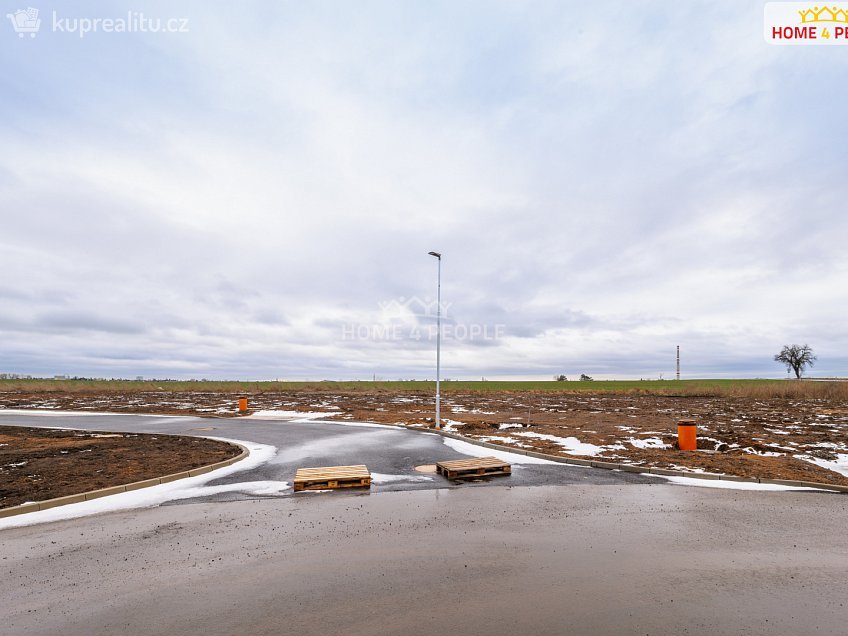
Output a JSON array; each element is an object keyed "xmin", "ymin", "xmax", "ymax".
[{"xmin": 0, "ymin": 414, "xmax": 664, "ymax": 504}]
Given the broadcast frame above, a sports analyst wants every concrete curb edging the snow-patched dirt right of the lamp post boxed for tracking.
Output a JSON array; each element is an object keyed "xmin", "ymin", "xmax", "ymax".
[{"xmin": 370, "ymin": 420, "xmax": 848, "ymax": 493}]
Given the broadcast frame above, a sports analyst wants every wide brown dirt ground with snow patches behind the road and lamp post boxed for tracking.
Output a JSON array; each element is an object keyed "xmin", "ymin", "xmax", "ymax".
[{"xmin": 0, "ymin": 389, "xmax": 848, "ymax": 485}]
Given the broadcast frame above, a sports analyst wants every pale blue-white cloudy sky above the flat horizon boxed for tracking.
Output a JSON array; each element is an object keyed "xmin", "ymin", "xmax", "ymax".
[{"xmin": 0, "ymin": 0, "xmax": 848, "ymax": 379}]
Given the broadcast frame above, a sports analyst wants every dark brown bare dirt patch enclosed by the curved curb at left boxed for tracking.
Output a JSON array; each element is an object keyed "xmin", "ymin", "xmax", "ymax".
[{"xmin": 0, "ymin": 426, "xmax": 241, "ymax": 508}]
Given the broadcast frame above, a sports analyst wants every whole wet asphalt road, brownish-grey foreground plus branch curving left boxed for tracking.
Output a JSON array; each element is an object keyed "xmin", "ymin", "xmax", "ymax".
[{"xmin": 0, "ymin": 410, "xmax": 848, "ymax": 636}]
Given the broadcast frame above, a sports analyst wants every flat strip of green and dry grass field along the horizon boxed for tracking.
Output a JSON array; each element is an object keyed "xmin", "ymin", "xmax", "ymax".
[{"xmin": 0, "ymin": 379, "xmax": 848, "ymax": 397}]
